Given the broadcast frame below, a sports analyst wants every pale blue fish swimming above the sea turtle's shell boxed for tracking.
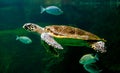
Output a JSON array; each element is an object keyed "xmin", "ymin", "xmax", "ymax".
[{"xmin": 40, "ymin": 6, "xmax": 63, "ymax": 15}]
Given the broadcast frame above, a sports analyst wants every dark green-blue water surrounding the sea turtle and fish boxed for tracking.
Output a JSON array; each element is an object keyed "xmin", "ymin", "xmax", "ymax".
[{"xmin": 0, "ymin": 0, "xmax": 120, "ymax": 73}]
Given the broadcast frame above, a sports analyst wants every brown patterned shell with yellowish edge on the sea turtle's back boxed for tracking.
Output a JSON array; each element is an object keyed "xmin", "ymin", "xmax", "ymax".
[{"xmin": 45, "ymin": 25, "xmax": 103, "ymax": 40}]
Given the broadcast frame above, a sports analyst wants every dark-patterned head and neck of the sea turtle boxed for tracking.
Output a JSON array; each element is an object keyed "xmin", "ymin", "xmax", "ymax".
[{"xmin": 23, "ymin": 23, "xmax": 43, "ymax": 33}]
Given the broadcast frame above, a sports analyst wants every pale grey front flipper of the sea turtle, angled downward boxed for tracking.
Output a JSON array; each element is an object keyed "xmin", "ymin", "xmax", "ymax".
[{"xmin": 41, "ymin": 33, "xmax": 63, "ymax": 49}]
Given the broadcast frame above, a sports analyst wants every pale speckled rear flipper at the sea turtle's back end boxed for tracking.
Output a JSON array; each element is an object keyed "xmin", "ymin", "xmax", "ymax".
[{"xmin": 91, "ymin": 41, "xmax": 107, "ymax": 53}]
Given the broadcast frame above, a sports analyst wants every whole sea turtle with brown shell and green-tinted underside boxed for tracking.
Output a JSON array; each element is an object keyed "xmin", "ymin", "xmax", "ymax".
[{"xmin": 23, "ymin": 23, "xmax": 106, "ymax": 54}]
